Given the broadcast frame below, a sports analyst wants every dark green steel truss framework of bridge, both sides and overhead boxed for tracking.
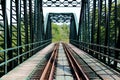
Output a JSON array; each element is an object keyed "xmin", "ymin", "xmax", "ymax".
[{"xmin": 0, "ymin": 0, "xmax": 120, "ymax": 76}]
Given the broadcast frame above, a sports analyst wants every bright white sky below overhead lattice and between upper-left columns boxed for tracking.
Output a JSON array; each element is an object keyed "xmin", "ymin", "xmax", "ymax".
[{"xmin": 6, "ymin": 0, "xmax": 80, "ymax": 23}]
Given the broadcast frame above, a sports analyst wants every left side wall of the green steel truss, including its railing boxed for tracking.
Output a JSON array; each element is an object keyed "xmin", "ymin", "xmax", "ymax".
[{"xmin": 0, "ymin": 0, "xmax": 50, "ymax": 76}]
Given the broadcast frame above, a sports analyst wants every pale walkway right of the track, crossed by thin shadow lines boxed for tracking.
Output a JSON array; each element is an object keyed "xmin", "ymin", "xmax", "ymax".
[{"xmin": 69, "ymin": 44, "xmax": 120, "ymax": 80}]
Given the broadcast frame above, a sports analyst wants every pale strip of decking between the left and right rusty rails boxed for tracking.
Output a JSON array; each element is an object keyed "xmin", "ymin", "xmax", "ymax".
[{"xmin": 55, "ymin": 44, "xmax": 74, "ymax": 80}]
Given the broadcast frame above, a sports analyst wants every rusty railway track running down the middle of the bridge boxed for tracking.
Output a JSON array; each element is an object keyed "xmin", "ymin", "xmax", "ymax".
[{"xmin": 31, "ymin": 43, "xmax": 101, "ymax": 80}]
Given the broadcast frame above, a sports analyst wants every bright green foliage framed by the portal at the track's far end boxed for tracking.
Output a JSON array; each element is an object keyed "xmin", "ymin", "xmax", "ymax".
[{"xmin": 52, "ymin": 23, "xmax": 69, "ymax": 42}]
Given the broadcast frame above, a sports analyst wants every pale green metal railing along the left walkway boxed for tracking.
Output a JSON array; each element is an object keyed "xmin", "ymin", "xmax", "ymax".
[{"xmin": 0, "ymin": 39, "xmax": 51, "ymax": 74}]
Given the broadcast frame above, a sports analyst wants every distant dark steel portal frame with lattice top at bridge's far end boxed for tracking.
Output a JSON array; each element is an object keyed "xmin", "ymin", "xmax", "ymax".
[{"xmin": 45, "ymin": 13, "xmax": 78, "ymax": 42}]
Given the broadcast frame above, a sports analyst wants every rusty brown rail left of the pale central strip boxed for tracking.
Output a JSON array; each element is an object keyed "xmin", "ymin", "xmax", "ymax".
[{"xmin": 40, "ymin": 43, "xmax": 59, "ymax": 80}]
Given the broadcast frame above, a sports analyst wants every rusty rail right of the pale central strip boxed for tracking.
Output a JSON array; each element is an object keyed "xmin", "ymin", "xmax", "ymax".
[{"xmin": 62, "ymin": 43, "xmax": 89, "ymax": 80}]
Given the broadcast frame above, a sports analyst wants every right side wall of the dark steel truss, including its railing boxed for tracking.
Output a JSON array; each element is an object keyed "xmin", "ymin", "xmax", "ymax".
[{"xmin": 72, "ymin": 0, "xmax": 120, "ymax": 71}]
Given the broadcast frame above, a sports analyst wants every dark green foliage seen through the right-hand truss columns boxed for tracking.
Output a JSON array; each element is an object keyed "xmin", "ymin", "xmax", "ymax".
[{"xmin": 90, "ymin": 1, "xmax": 120, "ymax": 47}]
